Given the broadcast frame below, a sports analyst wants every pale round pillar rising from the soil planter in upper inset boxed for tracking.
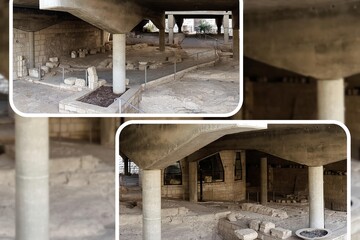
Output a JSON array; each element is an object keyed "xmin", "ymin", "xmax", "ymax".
[{"xmin": 113, "ymin": 33, "xmax": 126, "ymax": 94}]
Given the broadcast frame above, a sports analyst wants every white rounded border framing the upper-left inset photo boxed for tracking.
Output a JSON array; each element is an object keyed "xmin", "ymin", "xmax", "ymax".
[{"xmin": 9, "ymin": 0, "xmax": 244, "ymax": 118}]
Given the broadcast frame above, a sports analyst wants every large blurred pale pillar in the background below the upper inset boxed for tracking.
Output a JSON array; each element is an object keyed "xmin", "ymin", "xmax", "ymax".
[{"xmin": 15, "ymin": 115, "xmax": 49, "ymax": 240}]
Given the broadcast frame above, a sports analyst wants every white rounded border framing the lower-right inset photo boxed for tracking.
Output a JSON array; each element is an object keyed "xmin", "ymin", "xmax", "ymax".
[{"xmin": 115, "ymin": 120, "xmax": 351, "ymax": 240}]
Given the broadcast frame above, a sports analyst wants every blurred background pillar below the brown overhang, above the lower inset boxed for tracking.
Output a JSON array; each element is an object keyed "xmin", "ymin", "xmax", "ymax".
[{"xmin": 317, "ymin": 79, "xmax": 345, "ymax": 122}]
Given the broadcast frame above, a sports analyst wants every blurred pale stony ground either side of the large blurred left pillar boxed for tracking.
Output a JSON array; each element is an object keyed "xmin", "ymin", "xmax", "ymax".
[{"xmin": 0, "ymin": 142, "xmax": 115, "ymax": 240}]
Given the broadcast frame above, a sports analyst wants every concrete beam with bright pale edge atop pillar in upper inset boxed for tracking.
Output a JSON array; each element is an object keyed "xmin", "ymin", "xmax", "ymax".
[{"xmin": 40, "ymin": 0, "xmax": 157, "ymax": 34}]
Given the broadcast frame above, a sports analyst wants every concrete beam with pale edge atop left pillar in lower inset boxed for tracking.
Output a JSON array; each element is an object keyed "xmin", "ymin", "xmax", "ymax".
[{"xmin": 120, "ymin": 124, "xmax": 266, "ymax": 169}]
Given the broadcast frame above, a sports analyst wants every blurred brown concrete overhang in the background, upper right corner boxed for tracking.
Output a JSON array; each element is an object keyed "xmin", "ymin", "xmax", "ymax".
[{"xmin": 244, "ymin": 0, "xmax": 360, "ymax": 80}]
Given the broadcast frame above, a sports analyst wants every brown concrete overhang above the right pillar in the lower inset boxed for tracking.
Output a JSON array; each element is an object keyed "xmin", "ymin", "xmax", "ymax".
[{"xmin": 188, "ymin": 124, "xmax": 346, "ymax": 166}]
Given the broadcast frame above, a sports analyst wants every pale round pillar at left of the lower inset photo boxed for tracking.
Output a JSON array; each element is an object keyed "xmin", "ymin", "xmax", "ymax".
[{"xmin": 142, "ymin": 170, "xmax": 161, "ymax": 240}]
